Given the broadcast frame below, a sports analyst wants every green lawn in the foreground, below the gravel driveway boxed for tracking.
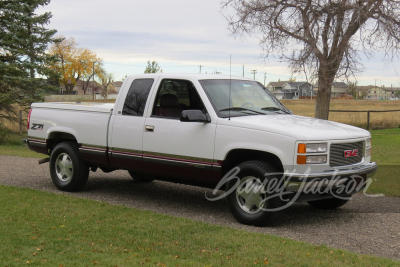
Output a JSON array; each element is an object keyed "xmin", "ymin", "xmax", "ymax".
[{"xmin": 0, "ymin": 185, "xmax": 399, "ymax": 266}]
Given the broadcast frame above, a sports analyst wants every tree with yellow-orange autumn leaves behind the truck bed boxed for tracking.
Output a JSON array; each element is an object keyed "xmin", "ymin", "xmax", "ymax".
[{"xmin": 50, "ymin": 36, "xmax": 102, "ymax": 94}]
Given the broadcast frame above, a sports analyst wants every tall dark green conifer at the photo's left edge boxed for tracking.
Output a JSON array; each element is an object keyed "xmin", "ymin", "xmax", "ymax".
[{"xmin": 0, "ymin": 0, "xmax": 60, "ymax": 129}]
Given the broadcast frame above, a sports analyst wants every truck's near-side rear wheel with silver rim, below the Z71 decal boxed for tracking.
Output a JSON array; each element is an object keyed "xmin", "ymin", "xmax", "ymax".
[{"xmin": 50, "ymin": 142, "xmax": 89, "ymax": 192}]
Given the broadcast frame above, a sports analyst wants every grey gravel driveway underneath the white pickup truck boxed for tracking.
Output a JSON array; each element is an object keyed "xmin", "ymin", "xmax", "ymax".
[{"xmin": 0, "ymin": 156, "xmax": 400, "ymax": 260}]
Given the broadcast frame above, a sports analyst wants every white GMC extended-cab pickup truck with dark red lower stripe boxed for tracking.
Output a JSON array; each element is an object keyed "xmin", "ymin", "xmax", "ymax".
[{"xmin": 25, "ymin": 74, "xmax": 377, "ymax": 225}]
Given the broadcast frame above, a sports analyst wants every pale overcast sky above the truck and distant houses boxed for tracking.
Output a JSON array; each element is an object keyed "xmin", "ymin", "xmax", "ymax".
[{"xmin": 39, "ymin": 0, "xmax": 400, "ymax": 86}]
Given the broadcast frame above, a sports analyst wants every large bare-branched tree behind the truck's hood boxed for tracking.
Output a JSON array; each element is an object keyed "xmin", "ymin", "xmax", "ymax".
[{"xmin": 223, "ymin": 0, "xmax": 400, "ymax": 119}]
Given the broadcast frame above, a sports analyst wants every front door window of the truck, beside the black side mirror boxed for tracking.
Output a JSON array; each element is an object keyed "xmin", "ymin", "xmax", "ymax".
[{"xmin": 152, "ymin": 79, "xmax": 206, "ymax": 118}]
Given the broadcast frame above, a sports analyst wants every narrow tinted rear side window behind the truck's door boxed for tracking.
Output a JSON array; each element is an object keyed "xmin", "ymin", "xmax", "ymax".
[{"xmin": 122, "ymin": 79, "xmax": 154, "ymax": 116}]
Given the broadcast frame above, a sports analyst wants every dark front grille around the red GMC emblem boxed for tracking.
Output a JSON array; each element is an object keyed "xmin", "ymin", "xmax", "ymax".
[{"xmin": 329, "ymin": 141, "xmax": 364, "ymax": 167}]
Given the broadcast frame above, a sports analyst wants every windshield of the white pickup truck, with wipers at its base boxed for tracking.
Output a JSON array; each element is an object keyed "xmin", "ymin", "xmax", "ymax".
[{"xmin": 199, "ymin": 80, "xmax": 289, "ymax": 117}]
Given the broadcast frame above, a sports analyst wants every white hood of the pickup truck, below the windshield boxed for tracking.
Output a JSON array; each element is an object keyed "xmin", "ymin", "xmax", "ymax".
[{"xmin": 218, "ymin": 114, "xmax": 370, "ymax": 141}]
